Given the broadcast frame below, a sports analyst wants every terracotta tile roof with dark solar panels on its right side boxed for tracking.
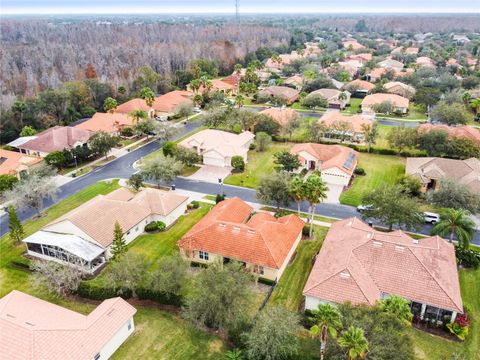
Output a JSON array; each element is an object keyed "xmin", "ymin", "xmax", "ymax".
[{"xmin": 290, "ymin": 143, "xmax": 358, "ymax": 175}]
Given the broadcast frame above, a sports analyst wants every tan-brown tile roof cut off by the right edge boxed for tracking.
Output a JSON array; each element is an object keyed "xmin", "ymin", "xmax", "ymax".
[{"xmin": 405, "ymin": 157, "xmax": 480, "ymax": 193}]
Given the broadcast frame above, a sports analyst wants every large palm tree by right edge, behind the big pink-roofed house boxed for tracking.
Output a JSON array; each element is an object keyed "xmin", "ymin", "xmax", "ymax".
[{"xmin": 432, "ymin": 209, "xmax": 476, "ymax": 249}]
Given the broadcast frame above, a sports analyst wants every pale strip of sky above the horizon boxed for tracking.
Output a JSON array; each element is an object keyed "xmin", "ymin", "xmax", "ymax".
[{"xmin": 0, "ymin": 0, "xmax": 480, "ymax": 14}]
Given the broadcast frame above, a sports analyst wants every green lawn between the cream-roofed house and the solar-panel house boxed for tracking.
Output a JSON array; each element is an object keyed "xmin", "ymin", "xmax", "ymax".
[{"xmin": 224, "ymin": 143, "xmax": 292, "ymax": 188}]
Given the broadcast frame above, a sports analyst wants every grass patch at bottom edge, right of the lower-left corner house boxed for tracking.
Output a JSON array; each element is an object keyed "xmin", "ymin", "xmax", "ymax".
[{"xmin": 112, "ymin": 307, "xmax": 226, "ymax": 360}]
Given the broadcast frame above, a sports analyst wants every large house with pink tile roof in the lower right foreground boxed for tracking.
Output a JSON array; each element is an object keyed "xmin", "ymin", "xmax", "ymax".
[{"xmin": 303, "ymin": 217, "xmax": 463, "ymax": 321}]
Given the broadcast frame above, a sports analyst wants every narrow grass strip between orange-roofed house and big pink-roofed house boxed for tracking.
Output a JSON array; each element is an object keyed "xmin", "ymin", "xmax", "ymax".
[{"xmin": 269, "ymin": 226, "xmax": 328, "ymax": 311}]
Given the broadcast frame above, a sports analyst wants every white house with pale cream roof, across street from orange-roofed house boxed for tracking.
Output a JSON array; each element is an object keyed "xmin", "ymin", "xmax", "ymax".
[{"xmin": 178, "ymin": 129, "xmax": 255, "ymax": 167}]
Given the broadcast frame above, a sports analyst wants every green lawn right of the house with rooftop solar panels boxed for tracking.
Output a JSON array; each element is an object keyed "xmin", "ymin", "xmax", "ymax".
[{"xmin": 340, "ymin": 153, "xmax": 405, "ymax": 206}]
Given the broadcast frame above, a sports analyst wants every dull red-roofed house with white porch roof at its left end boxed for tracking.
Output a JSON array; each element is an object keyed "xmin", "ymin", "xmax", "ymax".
[{"xmin": 8, "ymin": 126, "xmax": 93, "ymax": 158}]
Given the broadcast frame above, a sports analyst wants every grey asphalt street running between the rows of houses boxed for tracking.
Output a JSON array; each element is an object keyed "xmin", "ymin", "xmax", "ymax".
[{"xmin": 0, "ymin": 122, "xmax": 480, "ymax": 245}]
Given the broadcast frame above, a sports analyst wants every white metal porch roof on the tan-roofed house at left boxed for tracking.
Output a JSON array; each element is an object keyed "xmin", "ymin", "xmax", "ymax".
[{"xmin": 23, "ymin": 230, "xmax": 105, "ymax": 261}]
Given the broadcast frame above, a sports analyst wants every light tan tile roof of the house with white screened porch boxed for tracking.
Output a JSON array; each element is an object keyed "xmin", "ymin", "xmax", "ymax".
[{"xmin": 43, "ymin": 188, "xmax": 188, "ymax": 248}]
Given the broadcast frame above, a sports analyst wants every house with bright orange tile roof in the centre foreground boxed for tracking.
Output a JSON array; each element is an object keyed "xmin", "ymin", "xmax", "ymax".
[{"xmin": 178, "ymin": 197, "xmax": 304, "ymax": 281}]
